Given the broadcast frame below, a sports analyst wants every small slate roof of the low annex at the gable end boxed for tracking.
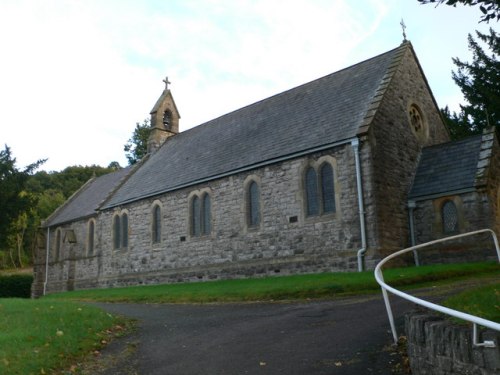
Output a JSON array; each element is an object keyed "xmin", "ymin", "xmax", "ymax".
[{"xmin": 408, "ymin": 135, "xmax": 482, "ymax": 199}]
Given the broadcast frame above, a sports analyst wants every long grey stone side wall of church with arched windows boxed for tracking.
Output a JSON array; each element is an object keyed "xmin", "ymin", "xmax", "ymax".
[{"xmin": 38, "ymin": 145, "xmax": 373, "ymax": 292}]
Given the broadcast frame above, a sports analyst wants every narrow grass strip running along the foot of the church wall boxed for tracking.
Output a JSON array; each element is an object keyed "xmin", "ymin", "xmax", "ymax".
[{"xmin": 48, "ymin": 262, "xmax": 500, "ymax": 303}]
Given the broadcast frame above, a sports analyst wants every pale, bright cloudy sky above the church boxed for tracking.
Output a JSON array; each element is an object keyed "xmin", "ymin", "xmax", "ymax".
[{"xmin": 0, "ymin": 0, "xmax": 492, "ymax": 171}]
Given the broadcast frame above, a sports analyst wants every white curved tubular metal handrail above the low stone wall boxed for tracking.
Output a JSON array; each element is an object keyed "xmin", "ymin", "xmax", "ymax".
[{"xmin": 375, "ymin": 229, "xmax": 500, "ymax": 347}]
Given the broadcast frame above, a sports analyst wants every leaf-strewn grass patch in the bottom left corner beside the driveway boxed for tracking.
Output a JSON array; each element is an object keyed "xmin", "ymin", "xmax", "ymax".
[{"xmin": 0, "ymin": 299, "xmax": 132, "ymax": 375}]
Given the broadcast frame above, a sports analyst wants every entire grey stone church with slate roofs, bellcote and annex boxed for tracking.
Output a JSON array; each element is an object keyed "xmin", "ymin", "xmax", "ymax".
[{"xmin": 33, "ymin": 41, "xmax": 500, "ymax": 296}]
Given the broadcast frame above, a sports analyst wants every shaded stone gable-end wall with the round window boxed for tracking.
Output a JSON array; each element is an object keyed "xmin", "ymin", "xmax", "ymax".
[{"xmin": 369, "ymin": 43, "xmax": 449, "ymax": 255}]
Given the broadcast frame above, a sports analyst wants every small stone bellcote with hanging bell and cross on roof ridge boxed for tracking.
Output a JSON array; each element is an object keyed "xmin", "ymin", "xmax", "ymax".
[{"xmin": 148, "ymin": 77, "xmax": 181, "ymax": 153}]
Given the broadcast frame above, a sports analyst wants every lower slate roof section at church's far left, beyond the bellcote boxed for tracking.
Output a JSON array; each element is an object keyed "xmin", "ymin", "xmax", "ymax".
[{"xmin": 43, "ymin": 167, "xmax": 131, "ymax": 227}]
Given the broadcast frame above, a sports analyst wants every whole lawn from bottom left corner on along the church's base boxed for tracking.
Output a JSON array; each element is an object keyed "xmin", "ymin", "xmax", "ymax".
[{"xmin": 0, "ymin": 262, "xmax": 500, "ymax": 375}]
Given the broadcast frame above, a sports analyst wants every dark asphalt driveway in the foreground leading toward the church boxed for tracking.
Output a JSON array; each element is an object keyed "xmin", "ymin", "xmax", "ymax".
[{"xmin": 88, "ymin": 295, "xmax": 412, "ymax": 375}]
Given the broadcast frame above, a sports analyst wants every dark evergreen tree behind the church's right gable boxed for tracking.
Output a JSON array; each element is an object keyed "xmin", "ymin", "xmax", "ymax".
[{"xmin": 443, "ymin": 29, "xmax": 500, "ymax": 137}]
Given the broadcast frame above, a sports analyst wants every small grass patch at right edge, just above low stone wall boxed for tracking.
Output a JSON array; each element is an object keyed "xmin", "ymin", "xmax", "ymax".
[{"xmin": 444, "ymin": 282, "xmax": 500, "ymax": 323}]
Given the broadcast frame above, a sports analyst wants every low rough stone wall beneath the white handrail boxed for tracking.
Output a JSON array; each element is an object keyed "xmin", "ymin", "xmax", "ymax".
[{"xmin": 405, "ymin": 312, "xmax": 500, "ymax": 375}]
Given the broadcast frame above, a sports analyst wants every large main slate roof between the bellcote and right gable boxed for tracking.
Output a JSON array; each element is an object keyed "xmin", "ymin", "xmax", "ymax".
[{"xmin": 103, "ymin": 43, "xmax": 409, "ymax": 208}]
